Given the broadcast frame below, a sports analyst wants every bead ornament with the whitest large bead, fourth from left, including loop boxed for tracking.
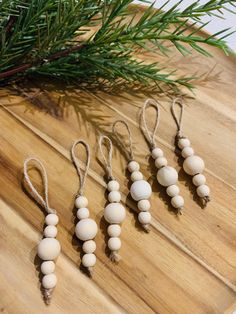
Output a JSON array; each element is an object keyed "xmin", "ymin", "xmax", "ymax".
[{"xmin": 112, "ymin": 120, "xmax": 152, "ymax": 232}]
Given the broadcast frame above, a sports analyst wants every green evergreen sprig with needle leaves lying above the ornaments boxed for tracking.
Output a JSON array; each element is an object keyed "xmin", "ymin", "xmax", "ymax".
[{"xmin": 0, "ymin": 0, "xmax": 236, "ymax": 90}]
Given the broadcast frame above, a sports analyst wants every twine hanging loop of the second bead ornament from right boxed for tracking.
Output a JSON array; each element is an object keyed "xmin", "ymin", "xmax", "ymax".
[{"xmin": 141, "ymin": 99, "xmax": 160, "ymax": 149}]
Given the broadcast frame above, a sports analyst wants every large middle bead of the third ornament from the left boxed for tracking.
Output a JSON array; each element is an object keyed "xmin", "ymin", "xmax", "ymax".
[{"xmin": 104, "ymin": 203, "xmax": 126, "ymax": 224}]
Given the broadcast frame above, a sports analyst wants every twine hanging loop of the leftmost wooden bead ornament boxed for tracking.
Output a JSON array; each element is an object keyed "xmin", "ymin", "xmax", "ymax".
[{"xmin": 24, "ymin": 157, "xmax": 56, "ymax": 214}]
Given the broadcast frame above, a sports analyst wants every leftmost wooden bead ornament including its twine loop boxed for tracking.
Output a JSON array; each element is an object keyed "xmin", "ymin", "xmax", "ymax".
[{"xmin": 24, "ymin": 158, "xmax": 61, "ymax": 304}]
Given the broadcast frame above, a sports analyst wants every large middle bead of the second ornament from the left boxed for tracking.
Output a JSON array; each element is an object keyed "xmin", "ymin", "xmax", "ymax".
[{"xmin": 75, "ymin": 218, "xmax": 98, "ymax": 241}]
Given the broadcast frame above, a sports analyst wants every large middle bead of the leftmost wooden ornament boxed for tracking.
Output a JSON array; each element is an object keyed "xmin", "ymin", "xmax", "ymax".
[{"xmin": 38, "ymin": 238, "xmax": 61, "ymax": 261}]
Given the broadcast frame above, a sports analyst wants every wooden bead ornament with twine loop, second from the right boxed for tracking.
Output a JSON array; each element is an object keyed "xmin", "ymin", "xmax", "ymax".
[{"xmin": 140, "ymin": 99, "xmax": 184, "ymax": 214}]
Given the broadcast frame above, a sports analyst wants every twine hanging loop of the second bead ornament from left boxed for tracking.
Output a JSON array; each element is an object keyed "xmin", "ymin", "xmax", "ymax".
[{"xmin": 71, "ymin": 139, "xmax": 90, "ymax": 196}]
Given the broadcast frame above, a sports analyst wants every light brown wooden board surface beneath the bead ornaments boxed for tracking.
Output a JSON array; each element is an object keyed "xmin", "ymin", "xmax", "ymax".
[{"xmin": 0, "ymin": 7, "xmax": 236, "ymax": 314}]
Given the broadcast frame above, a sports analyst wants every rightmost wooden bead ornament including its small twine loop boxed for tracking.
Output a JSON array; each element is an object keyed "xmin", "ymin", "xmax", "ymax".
[{"xmin": 171, "ymin": 98, "xmax": 210, "ymax": 207}]
